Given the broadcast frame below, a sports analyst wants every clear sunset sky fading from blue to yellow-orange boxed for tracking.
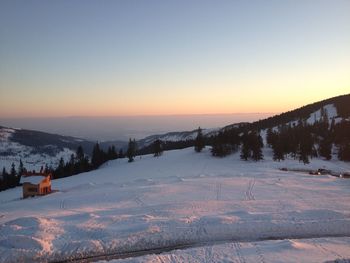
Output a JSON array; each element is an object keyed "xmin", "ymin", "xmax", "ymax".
[{"xmin": 0, "ymin": 0, "xmax": 350, "ymax": 118}]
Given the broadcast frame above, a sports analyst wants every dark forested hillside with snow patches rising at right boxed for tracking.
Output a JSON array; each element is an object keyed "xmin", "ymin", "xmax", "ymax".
[{"xmin": 206, "ymin": 94, "xmax": 350, "ymax": 164}]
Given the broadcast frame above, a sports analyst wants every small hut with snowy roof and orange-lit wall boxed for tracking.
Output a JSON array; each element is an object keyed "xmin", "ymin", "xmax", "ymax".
[{"xmin": 20, "ymin": 172, "xmax": 51, "ymax": 198}]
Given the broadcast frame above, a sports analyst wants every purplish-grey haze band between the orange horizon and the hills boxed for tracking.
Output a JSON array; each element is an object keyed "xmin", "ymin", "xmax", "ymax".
[{"xmin": 0, "ymin": 113, "xmax": 274, "ymax": 141}]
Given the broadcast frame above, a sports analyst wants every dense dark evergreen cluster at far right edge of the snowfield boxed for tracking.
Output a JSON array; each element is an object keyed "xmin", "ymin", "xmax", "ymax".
[{"xmin": 266, "ymin": 108, "xmax": 350, "ymax": 163}]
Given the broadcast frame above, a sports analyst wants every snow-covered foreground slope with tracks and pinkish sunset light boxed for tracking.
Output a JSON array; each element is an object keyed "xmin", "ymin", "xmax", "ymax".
[{"xmin": 0, "ymin": 148, "xmax": 350, "ymax": 262}]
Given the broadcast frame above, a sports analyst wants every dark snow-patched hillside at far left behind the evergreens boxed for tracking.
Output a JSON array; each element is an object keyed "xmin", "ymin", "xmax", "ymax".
[{"xmin": 0, "ymin": 126, "xmax": 126, "ymax": 170}]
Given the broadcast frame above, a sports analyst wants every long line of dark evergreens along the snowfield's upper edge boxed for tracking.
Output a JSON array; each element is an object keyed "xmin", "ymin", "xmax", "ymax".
[{"xmin": 0, "ymin": 100, "xmax": 350, "ymax": 193}]
